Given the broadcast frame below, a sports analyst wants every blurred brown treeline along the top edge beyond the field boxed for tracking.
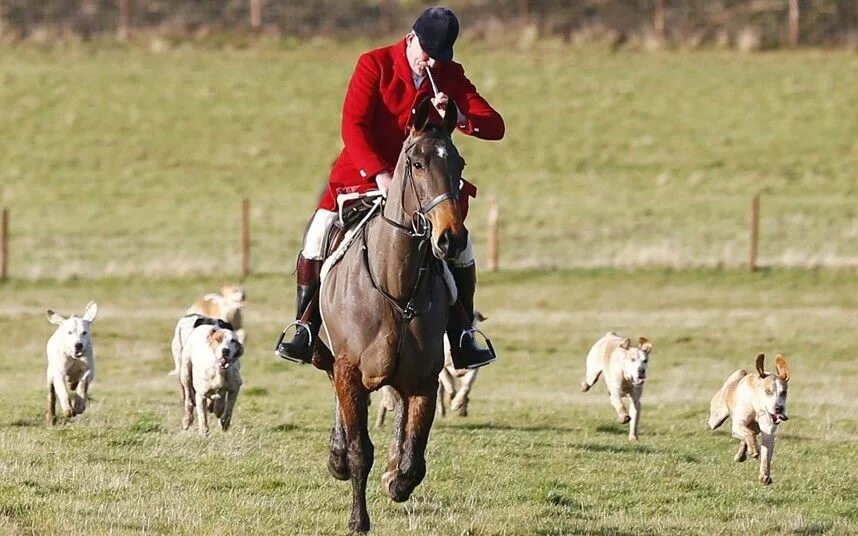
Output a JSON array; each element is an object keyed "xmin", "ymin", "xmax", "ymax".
[{"xmin": 0, "ymin": 0, "xmax": 858, "ymax": 48}]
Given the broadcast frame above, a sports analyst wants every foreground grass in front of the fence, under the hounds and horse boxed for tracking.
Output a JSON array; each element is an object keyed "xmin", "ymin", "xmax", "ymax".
[{"xmin": 0, "ymin": 270, "xmax": 858, "ymax": 535}]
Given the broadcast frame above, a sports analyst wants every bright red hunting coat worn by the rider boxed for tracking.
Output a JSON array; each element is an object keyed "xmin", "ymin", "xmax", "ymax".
[{"xmin": 319, "ymin": 39, "xmax": 504, "ymax": 217}]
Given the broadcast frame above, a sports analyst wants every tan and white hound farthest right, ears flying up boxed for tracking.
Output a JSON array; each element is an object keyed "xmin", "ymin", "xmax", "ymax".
[{"xmin": 709, "ymin": 354, "xmax": 790, "ymax": 485}]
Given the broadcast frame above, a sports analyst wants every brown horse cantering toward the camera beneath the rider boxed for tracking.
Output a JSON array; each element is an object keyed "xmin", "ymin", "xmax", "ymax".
[{"xmin": 314, "ymin": 100, "xmax": 467, "ymax": 532}]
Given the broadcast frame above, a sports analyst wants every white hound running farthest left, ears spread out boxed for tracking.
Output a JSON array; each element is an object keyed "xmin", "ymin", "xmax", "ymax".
[{"xmin": 45, "ymin": 302, "xmax": 98, "ymax": 426}]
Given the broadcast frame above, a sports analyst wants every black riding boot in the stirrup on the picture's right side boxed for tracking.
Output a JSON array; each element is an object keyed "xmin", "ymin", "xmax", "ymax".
[{"xmin": 447, "ymin": 264, "xmax": 496, "ymax": 369}]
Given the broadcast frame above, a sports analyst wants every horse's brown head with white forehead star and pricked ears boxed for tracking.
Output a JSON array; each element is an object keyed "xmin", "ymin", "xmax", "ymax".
[{"xmin": 391, "ymin": 99, "xmax": 468, "ymax": 260}]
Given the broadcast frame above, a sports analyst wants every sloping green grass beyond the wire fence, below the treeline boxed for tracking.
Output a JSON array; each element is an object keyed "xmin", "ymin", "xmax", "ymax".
[{"xmin": 0, "ymin": 42, "xmax": 858, "ymax": 279}]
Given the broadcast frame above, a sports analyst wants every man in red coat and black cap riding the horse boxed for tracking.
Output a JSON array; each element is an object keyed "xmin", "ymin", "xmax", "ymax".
[{"xmin": 275, "ymin": 7, "xmax": 504, "ymax": 368}]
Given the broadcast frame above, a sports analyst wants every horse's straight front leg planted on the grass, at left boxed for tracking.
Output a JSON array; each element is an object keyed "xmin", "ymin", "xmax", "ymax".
[{"xmin": 334, "ymin": 359, "xmax": 374, "ymax": 532}]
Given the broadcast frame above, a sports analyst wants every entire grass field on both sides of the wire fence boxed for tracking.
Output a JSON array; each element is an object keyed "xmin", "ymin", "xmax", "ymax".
[{"xmin": 0, "ymin": 42, "xmax": 858, "ymax": 536}]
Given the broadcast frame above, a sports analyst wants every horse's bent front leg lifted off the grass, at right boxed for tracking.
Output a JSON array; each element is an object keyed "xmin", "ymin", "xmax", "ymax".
[{"xmin": 385, "ymin": 377, "xmax": 438, "ymax": 502}]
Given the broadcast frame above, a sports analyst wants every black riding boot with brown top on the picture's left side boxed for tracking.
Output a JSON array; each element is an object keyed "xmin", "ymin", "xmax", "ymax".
[{"xmin": 274, "ymin": 255, "xmax": 322, "ymax": 363}]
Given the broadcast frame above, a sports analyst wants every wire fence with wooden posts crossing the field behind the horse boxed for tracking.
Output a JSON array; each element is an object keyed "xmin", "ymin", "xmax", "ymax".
[{"xmin": 0, "ymin": 195, "xmax": 858, "ymax": 280}]
